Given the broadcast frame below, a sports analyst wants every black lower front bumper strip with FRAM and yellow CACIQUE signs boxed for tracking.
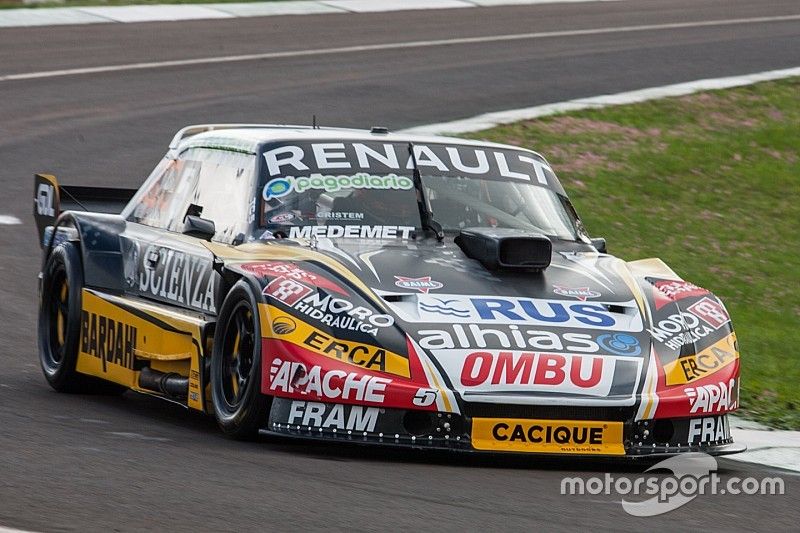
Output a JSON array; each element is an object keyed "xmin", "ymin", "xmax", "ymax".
[{"xmin": 261, "ymin": 398, "xmax": 746, "ymax": 457}]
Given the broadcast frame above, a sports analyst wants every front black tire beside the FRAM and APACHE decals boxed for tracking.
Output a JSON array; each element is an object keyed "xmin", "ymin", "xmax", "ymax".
[{"xmin": 211, "ymin": 280, "xmax": 271, "ymax": 440}]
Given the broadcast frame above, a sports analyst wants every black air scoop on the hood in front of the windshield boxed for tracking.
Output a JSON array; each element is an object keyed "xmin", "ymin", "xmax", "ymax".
[{"xmin": 455, "ymin": 228, "xmax": 553, "ymax": 272}]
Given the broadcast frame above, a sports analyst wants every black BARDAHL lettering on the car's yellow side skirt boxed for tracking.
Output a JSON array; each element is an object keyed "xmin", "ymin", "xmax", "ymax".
[{"xmin": 81, "ymin": 311, "xmax": 137, "ymax": 372}]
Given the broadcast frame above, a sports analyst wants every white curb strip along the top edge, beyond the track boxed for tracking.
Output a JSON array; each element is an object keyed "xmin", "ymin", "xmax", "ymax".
[{"xmin": 0, "ymin": 0, "xmax": 630, "ymax": 28}]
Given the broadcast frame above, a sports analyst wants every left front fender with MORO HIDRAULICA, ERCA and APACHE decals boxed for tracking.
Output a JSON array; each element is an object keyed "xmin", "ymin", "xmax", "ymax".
[{"xmin": 216, "ymin": 260, "xmax": 458, "ymax": 412}]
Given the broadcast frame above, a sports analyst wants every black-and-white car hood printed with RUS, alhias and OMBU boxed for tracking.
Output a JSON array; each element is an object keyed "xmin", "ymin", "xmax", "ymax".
[{"xmin": 227, "ymin": 239, "xmax": 649, "ymax": 405}]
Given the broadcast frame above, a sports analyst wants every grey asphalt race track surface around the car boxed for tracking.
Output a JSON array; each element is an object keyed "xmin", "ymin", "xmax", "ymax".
[{"xmin": 0, "ymin": 0, "xmax": 800, "ymax": 531}]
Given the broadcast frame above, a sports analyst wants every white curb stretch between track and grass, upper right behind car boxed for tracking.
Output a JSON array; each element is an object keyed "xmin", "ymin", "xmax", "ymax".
[{"xmin": 402, "ymin": 67, "xmax": 800, "ymax": 135}]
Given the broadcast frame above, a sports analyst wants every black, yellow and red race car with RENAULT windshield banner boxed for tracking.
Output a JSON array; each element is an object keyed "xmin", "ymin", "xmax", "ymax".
[{"xmin": 34, "ymin": 124, "xmax": 744, "ymax": 457}]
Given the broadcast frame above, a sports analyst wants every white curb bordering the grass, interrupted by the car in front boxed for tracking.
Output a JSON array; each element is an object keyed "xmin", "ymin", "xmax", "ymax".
[{"xmin": 402, "ymin": 67, "xmax": 800, "ymax": 472}]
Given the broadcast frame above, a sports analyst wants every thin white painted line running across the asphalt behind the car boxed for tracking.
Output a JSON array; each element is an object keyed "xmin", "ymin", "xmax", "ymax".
[{"xmin": 0, "ymin": 14, "xmax": 800, "ymax": 82}]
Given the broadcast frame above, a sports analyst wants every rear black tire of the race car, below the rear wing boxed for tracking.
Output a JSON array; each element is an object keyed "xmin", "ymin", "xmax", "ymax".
[{"xmin": 39, "ymin": 242, "xmax": 126, "ymax": 394}]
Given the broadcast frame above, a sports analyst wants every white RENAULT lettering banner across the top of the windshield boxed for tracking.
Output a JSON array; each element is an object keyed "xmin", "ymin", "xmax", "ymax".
[{"xmin": 263, "ymin": 142, "xmax": 554, "ymax": 185}]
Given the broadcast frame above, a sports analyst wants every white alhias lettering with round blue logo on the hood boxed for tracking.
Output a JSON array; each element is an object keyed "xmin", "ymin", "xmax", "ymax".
[{"xmin": 417, "ymin": 324, "xmax": 641, "ymax": 355}]
